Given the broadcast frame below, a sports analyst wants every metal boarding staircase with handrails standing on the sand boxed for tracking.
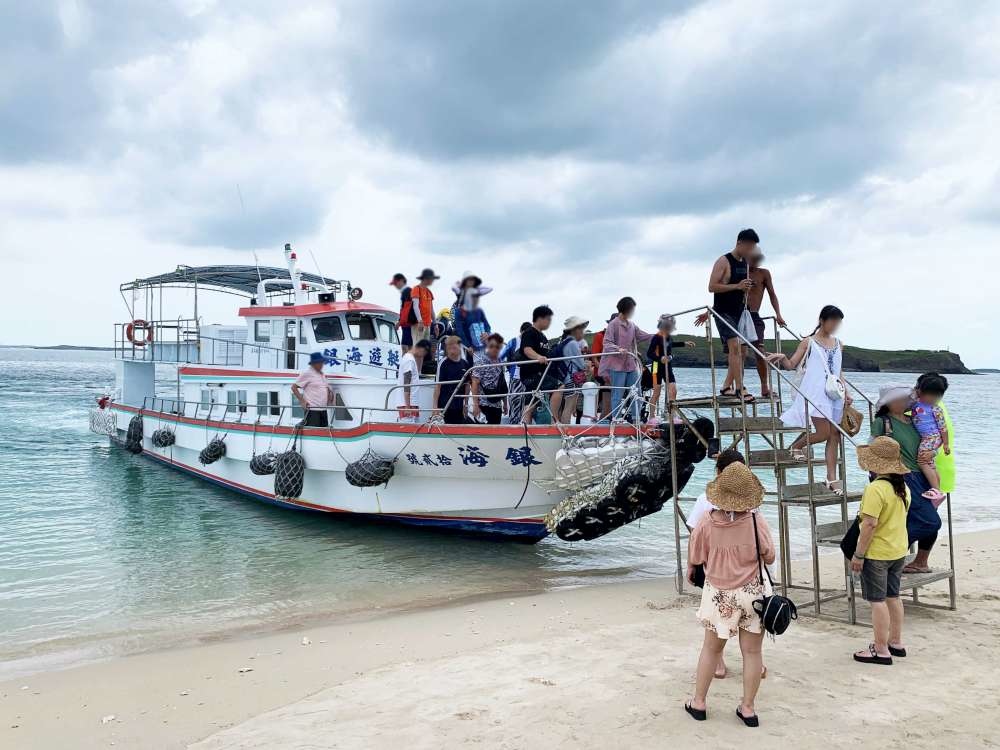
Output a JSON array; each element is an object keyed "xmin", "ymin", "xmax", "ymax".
[{"xmin": 651, "ymin": 308, "xmax": 957, "ymax": 624}]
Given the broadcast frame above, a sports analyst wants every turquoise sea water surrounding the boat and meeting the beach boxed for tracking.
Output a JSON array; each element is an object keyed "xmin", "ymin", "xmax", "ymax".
[{"xmin": 0, "ymin": 349, "xmax": 1000, "ymax": 678}]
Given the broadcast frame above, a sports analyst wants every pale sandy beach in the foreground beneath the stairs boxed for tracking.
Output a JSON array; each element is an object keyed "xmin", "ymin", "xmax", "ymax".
[{"xmin": 0, "ymin": 531, "xmax": 1000, "ymax": 750}]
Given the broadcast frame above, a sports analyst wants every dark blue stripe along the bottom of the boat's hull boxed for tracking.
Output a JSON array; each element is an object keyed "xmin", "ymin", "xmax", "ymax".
[{"xmin": 135, "ymin": 450, "xmax": 549, "ymax": 544}]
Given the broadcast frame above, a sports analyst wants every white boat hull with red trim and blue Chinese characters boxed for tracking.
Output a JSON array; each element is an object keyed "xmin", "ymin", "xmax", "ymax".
[{"xmin": 110, "ymin": 404, "xmax": 634, "ymax": 542}]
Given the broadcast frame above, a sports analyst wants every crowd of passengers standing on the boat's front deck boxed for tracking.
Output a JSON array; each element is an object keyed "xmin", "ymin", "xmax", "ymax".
[{"xmin": 390, "ymin": 268, "xmax": 693, "ymax": 424}]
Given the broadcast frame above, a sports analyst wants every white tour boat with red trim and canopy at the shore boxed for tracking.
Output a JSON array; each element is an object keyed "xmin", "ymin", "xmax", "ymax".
[{"xmin": 91, "ymin": 245, "xmax": 703, "ymax": 542}]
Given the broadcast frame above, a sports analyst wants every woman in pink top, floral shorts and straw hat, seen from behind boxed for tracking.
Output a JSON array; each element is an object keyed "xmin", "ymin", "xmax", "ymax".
[{"xmin": 684, "ymin": 463, "xmax": 775, "ymax": 727}]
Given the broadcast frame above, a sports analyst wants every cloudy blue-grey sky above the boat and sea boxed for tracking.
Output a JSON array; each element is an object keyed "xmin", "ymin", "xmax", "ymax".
[{"xmin": 0, "ymin": 0, "xmax": 1000, "ymax": 367}]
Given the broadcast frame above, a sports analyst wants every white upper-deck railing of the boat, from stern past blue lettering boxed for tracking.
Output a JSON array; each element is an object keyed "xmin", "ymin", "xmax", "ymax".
[{"xmin": 114, "ymin": 318, "xmax": 396, "ymax": 380}]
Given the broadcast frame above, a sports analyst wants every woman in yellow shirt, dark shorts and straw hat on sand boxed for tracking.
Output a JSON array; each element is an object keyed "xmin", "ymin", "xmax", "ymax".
[{"xmin": 851, "ymin": 436, "xmax": 910, "ymax": 664}]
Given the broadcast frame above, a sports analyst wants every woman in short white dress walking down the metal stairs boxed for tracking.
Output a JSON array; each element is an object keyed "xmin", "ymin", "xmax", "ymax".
[{"xmin": 768, "ymin": 305, "xmax": 851, "ymax": 494}]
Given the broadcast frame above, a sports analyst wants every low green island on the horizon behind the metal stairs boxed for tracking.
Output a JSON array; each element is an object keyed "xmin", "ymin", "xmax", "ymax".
[{"xmin": 673, "ymin": 335, "xmax": 976, "ymax": 375}]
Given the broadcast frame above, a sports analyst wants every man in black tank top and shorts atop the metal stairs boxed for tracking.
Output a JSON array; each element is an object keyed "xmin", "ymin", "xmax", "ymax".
[{"xmin": 695, "ymin": 229, "xmax": 760, "ymax": 402}]
